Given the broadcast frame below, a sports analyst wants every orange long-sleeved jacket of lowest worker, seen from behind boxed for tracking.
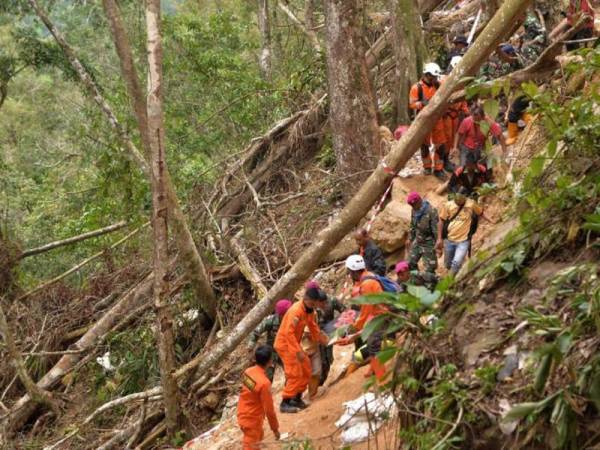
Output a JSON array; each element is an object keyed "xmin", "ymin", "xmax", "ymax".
[{"xmin": 237, "ymin": 365, "xmax": 279, "ymax": 431}]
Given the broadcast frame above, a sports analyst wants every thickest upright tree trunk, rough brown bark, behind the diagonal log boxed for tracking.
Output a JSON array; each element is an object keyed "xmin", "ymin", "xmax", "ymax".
[{"xmin": 325, "ymin": 0, "xmax": 379, "ymax": 182}]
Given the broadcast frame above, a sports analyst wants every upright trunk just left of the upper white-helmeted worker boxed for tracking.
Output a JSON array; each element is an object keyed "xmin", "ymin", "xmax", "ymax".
[{"xmin": 388, "ymin": 0, "xmax": 424, "ymax": 125}]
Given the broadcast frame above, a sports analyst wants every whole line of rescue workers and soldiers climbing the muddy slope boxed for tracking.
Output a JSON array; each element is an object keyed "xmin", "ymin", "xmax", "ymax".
[{"xmin": 233, "ymin": 0, "xmax": 594, "ymax": 450}]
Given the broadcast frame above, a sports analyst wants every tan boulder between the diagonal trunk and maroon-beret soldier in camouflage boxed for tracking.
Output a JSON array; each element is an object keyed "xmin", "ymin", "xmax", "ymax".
[{"xmin": 371, "ymin": 201, "xmax": 411, "ymax": 253}]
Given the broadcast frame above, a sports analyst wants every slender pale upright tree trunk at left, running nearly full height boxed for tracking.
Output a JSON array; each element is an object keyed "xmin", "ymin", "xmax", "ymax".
[{"xmin": 146, "ymin": 0, "xmax": 180, "ymax": 439}]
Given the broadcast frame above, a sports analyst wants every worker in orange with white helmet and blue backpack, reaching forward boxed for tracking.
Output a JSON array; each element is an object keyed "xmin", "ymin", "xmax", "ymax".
[{"xmin": 338, "ymin": 255, "xmax": 388, "ymax": 380}]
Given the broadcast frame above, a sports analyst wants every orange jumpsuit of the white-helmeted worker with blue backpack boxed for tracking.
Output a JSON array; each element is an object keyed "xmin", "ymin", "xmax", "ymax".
[{"xmin": 353, "ymin": 272, "xmax": 388, "ymax": 380}]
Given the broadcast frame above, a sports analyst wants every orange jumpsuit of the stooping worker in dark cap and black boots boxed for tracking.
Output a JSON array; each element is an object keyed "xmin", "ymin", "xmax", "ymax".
[{"xmin": 275, "ymin": 301, "xmax": 321, "ymax": 399}]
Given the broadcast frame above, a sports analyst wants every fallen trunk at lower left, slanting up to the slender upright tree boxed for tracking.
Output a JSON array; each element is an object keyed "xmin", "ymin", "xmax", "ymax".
[{"xmin": 6, "ymin": 274, "xmax": 154, "ymax": 433}]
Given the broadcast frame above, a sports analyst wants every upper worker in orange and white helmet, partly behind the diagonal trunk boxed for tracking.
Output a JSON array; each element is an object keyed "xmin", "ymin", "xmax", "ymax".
[{"xmin": 409, "ymin": 63, "xmax": 446, "ymax": 180}]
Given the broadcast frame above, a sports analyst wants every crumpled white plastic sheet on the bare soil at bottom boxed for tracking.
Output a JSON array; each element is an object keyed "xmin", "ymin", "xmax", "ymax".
[{"xmin": 335, "ymin": 392, "xmax": 395, "ymax": 444}]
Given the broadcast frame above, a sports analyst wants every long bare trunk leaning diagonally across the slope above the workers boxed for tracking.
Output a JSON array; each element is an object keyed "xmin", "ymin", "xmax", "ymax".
[{"xmin": 175, "ymin": 0, "xmax": 532, "ymax": 384}]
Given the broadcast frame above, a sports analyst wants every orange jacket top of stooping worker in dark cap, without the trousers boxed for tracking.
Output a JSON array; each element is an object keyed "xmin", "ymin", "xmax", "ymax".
[{"xmin": 275, "ymin": 301, "xmax": 321, "ymax": 361}]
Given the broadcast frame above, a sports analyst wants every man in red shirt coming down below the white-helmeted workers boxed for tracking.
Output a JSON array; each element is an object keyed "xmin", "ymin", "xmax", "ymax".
[{"xmin": 453, "ymin": 104, "xmax": 507, "ymax": 167}]
